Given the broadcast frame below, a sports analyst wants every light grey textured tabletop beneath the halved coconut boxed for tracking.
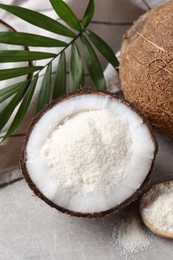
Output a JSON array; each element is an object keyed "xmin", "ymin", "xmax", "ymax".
[{"xmin": 0, "ymin": 136, "xmax": 173, "ymax": 260}]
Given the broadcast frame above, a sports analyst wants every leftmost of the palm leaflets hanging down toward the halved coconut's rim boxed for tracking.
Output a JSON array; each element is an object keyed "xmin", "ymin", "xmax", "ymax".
[{"xmin": 36, "ymin": 63, "xmax": 52, "ymax": 113}]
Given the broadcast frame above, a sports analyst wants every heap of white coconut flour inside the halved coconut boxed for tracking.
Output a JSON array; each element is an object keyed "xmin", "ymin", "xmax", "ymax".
[{"xmin": 41, "ymin": 110, "xmax": 132, "ymax": 193}]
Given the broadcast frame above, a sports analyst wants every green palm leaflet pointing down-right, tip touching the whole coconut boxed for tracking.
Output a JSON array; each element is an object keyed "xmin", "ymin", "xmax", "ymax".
[{"xmin": 87, "ymin": 30, "xmax": 119, "ymax": 67}]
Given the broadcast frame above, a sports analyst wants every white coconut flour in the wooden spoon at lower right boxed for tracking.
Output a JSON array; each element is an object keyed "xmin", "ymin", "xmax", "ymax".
[{"xmin": 141, "ymin": 182, "xmax": 173, "ymax": 233}]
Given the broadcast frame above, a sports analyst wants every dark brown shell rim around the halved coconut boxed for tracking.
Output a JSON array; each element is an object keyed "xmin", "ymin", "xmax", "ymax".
[{"xmin": 20, "ymin": 88, "xmax": 158, "ymax": 218}]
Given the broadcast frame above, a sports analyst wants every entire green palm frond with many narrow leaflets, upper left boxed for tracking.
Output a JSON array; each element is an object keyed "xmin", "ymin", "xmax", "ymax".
[{"xmin": 0, "ymin": 0, "xmax": 118, "ymax": 142}]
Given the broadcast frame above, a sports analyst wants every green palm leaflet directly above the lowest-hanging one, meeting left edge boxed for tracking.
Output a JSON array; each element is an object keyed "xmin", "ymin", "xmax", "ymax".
[{"xmin": 0, "ymin": 82, "xmax": 28, "ymax": 130}]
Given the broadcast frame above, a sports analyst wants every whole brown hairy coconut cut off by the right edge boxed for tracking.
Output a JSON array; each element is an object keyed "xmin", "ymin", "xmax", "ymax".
[{"xmin": 119, "ymin": 2, "xmax": 173, "ymax": 137}]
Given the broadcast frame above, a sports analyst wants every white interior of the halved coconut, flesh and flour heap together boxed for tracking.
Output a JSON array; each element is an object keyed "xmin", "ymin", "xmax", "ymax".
[{"xmin": 26, "ymin": 94, "xmax": 155, "ymax": 213}]
